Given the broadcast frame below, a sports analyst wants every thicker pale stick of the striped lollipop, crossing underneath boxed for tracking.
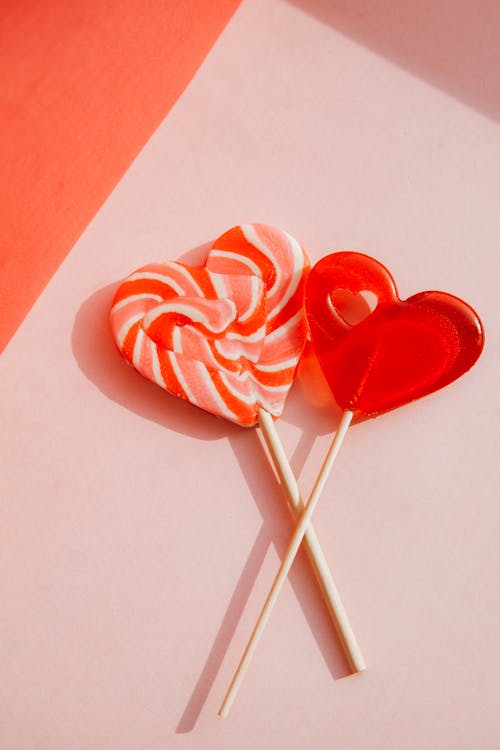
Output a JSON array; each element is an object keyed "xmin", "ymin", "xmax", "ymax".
[{"xmin": 259, "ymin": 409, "xmax": 366, "ymax": 672}]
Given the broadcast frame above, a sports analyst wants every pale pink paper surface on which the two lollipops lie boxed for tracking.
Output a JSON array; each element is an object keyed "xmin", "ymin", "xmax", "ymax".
[{"xmin": 0, "ymin": 0, "xmax": 500, "ymax": 750}]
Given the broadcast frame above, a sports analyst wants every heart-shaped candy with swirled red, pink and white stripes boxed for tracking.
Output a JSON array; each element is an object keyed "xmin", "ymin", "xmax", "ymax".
[{"xmin": 111, "ymin": 224, "xmax": 309, "ymax": 427}]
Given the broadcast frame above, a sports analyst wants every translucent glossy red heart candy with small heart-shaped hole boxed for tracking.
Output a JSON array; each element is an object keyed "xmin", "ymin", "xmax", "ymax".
[{"xmin": 305, "ymin": 252, "xmax": 484, "ymax": 416}]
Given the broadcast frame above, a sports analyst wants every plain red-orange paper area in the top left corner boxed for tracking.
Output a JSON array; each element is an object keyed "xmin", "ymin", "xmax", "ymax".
[{"xmin": 0, "ymin": 0, "xmax": 239, "ymax": 350}]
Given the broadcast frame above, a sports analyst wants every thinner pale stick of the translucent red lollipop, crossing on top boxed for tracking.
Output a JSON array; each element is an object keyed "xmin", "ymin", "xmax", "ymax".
[{"xmin": 219, "ymin": 410, "xmax": 353, "ymax": 717}]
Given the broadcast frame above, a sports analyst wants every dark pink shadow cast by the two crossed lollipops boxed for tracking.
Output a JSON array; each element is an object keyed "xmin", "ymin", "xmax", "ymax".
[{"xmin": 71, "ymin": 245, "xmax": 356, "ymax": 733}]
